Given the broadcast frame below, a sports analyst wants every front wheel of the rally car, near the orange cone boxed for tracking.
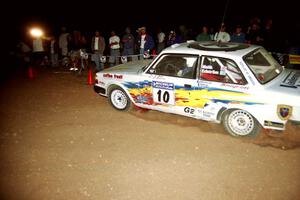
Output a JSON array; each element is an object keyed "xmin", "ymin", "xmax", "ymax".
[{"xmin": 108, "ymin": 86, "xmax": 132, "ymax": 111}]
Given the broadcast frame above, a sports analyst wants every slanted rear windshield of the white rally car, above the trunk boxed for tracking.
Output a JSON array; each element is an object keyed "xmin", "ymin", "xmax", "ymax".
[{"xmin": 244, "ymin": 48, "xmax": 283, "ymax": 84}]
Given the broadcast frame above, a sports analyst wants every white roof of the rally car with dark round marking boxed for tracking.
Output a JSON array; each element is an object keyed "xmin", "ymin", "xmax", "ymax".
[{"xmin": 163, "ymin": 41, "xmax": 259, "ymax": 56}]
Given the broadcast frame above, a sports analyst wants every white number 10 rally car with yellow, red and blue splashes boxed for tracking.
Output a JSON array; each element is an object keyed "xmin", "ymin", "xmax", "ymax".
[{"xmin": 94, "ymin": 41, "xmax": 300, "ymax": 136}]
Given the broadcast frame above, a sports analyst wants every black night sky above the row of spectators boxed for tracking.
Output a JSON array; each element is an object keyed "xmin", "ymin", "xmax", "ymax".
[{"xmin": 1, "ymin": 0, "xmax": 300, "ymax": 49}]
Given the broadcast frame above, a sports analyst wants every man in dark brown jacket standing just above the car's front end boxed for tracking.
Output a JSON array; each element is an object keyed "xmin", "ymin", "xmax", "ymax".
[{"xmin": 91, "ymin": 31, "xmax": 105, "ymax": 71}]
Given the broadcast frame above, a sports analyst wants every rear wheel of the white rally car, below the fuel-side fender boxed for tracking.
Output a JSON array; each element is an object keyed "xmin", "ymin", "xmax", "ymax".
[{"xmin": 222, "ymin": 110, "xmax": 261, "ymax": 136}]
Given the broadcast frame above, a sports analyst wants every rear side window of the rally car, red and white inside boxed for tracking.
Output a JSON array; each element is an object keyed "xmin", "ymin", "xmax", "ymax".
[{"xmin": 200, "ymin": 56, "xmax": 247, "ymax": 85}]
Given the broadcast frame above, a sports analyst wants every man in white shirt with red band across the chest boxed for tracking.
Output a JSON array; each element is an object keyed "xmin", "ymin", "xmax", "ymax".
[{"xmin": 109, "ymin": 31, "xmax": 120, "ymax": 66}]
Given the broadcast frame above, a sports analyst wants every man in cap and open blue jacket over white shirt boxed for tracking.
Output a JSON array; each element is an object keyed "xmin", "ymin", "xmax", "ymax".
[{"xmin": 137, "ymin": 26, "xmax": 154, "ymax": 59}]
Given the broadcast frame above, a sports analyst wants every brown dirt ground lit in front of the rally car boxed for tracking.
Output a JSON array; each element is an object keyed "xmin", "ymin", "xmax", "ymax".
[{"xmin": 0, "ymin": 69, "xmax": 300, "ymax": 200}]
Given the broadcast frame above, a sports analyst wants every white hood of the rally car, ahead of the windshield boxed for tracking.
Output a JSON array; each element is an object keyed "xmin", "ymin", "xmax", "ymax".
[{"xmin": 101, "ymin": 59, "xmax": 152, "ymax": 74}]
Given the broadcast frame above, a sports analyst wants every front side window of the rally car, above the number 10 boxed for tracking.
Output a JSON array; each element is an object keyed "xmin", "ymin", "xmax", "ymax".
[{"xmin": 147, "ymin": 54, "xmax": 198, "ymax": 79}]
